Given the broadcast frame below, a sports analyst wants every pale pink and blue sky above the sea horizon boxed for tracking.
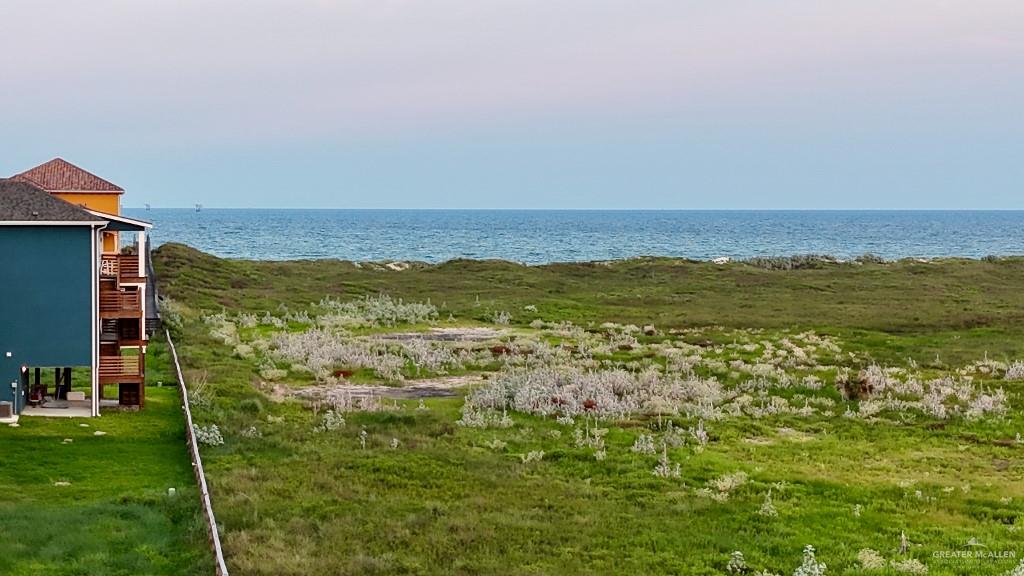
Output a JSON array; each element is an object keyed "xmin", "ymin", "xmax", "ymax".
[{"xmin": 0, "ymin": 0, "xmax": 1024, "ymax": 209}]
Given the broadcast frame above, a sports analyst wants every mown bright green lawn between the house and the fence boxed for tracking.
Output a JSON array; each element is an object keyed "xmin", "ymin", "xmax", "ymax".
[{"xmin": 0, "ymin": 343, "xmax": 212, "ymax": 576}]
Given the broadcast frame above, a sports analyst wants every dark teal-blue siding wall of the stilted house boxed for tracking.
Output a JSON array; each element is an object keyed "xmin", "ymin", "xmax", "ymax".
[{"xmin": 0, "ymin": 225, "xmax": 92, "ymax": 411}]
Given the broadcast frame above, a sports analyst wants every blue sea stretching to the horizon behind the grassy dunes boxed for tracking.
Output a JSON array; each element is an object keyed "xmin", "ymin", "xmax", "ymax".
[{"xmin": 126, "ymin": 209, "xmax": 1024, "ymax": 263}]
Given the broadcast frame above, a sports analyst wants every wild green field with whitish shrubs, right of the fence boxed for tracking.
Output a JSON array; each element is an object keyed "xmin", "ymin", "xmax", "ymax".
[{"xmin": 155, "ymin": 245, "xmax": 1024, "ymax": 575}]
